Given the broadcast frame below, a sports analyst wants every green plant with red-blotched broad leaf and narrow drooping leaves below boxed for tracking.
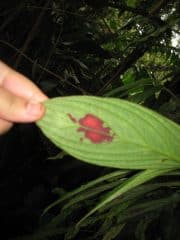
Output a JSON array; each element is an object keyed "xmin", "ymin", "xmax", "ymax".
[{"xmin": 33, "ymin": 96, "xmax": 180, "ymax": 239}]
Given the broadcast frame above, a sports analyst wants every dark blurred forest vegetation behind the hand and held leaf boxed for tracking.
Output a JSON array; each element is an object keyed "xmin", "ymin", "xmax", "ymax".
[{"xmin": 0, "ymin": 0, "xmax": 180, "ymax": 240}]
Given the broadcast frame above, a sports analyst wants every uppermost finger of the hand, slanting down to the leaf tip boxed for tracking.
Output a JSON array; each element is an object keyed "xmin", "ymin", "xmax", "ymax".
[{"xmin": 0, "ymin": 61, "xmax": 47, "ymax": 101}]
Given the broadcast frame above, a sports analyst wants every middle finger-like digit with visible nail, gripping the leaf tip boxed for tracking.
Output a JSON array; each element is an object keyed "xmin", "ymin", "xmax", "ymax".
[{"xmin": 0, "ymin": 87, "xmax": 45, "ymax": 122}]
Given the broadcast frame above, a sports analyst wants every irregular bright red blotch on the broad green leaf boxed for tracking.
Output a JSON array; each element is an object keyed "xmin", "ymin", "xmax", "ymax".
[{"xmin": 67, "ymin": 113, "xmax": 114, "ymax": 144}]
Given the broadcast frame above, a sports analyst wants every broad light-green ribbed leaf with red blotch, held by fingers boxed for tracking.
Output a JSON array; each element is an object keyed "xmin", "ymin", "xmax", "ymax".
[{"xmin": 37, "ymin": 96, "xmax": 180, "ymax": 169}]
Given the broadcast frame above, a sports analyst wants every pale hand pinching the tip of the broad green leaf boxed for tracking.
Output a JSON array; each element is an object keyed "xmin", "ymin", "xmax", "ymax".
[{"xmin": 0, "ymin": 61, "xmax": 47, "ymax": 135}]
